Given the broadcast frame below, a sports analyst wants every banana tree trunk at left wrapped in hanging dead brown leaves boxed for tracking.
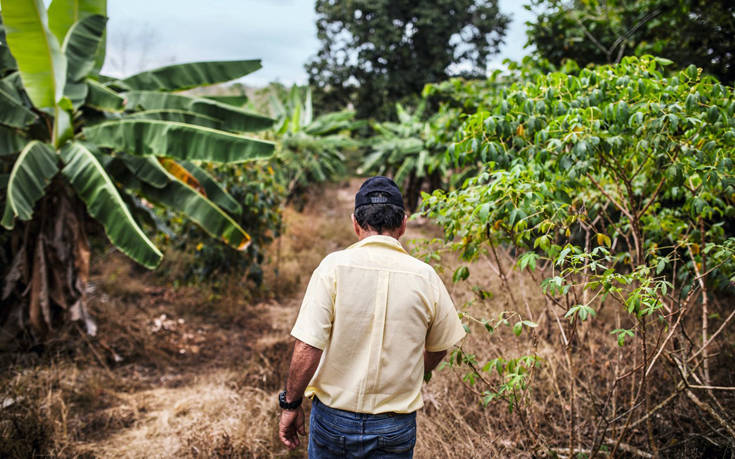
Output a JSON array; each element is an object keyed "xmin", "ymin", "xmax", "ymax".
[{"xmin": 0, "ymin": 179, "xmax": 96, "ymax": 348}]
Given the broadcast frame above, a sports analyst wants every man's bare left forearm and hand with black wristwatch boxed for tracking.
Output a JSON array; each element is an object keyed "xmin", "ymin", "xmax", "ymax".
[{"xmin": 278, "ymin": 339, "xmax": 322, "ymax": 449}]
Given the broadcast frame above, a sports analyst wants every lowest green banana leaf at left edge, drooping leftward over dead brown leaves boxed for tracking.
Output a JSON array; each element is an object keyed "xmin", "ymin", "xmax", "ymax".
[{"xmin": 1, "ymin": 140, "xmax": 59, "ymax": 230}]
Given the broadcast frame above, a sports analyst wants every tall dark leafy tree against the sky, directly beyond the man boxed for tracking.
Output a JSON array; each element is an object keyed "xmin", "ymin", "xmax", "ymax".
[{"xmin": 306, "ymin": 0, "xmax": 510, "ymax": 118}]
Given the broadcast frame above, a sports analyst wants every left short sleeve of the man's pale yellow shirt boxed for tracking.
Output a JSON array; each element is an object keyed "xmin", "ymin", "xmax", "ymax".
[{"xmin": 291, "ymin": 266, "xmax": 334, "ymax": 350}]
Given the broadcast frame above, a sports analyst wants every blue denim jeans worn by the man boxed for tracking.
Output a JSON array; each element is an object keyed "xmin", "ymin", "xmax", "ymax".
[{"xmin": 309, "ymin": 397, "xmax": 416, "ymax": 459}]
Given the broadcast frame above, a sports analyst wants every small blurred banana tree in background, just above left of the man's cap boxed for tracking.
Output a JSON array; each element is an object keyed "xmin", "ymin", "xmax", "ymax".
[{"xmin": 270, "ymin": 86, "xmax": 357, "ymax": 198}]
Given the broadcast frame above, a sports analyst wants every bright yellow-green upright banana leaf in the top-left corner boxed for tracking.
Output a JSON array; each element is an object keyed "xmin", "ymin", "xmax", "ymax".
[{"xmin": 0, "ymin": 0, "xmax": 66, "ymax": 108}]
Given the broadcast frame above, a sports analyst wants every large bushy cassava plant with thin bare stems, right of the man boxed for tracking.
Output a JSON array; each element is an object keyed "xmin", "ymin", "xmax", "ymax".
[{"xmin": 423, "ymin": 56, "xmax": 735, "ymax": 457}]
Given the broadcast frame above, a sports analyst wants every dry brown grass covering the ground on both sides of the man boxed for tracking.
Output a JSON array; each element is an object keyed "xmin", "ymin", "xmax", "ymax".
[{"xmin": 0, "ymin": 181, "xmax": 735, "ymax": 458}]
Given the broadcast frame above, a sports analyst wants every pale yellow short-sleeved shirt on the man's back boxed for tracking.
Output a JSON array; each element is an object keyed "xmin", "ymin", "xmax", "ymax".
[{"xmin": 291, "ymin": 236, "xmax": 465, "ymax": 413}]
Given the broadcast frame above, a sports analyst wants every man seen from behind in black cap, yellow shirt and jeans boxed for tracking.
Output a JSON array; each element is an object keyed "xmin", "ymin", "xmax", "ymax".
[{"xmin": 279, "ymin": 176, "xmax": 465, "ymax": 458}]
